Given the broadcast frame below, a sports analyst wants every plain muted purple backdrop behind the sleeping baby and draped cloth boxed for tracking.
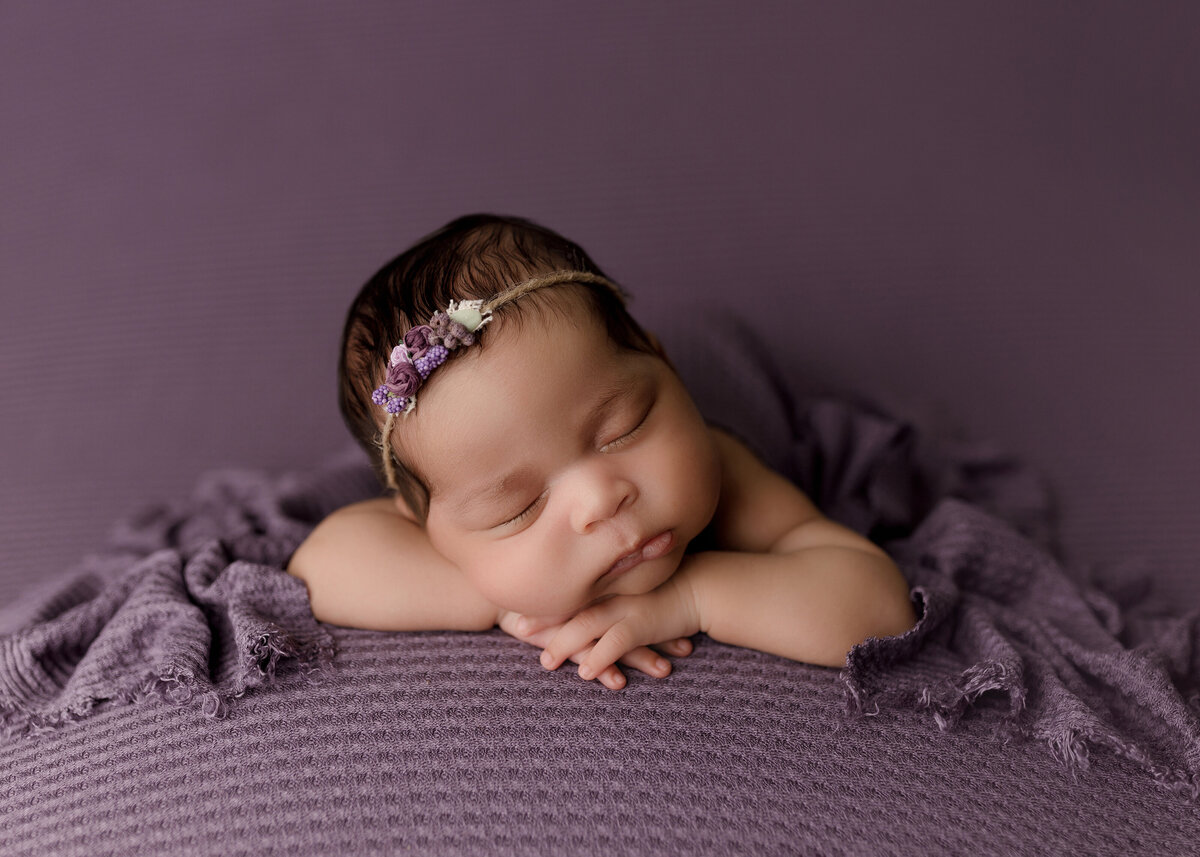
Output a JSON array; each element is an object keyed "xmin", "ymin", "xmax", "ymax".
[{"xmin": 0, "ymin": 2, "xmax": 1200, "ymax": 605}]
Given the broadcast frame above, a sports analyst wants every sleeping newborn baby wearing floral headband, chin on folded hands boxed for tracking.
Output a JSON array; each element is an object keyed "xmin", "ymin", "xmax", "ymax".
[{"xmin": 288, "ymin": 215, "xmax": 916, "ymax": 689}]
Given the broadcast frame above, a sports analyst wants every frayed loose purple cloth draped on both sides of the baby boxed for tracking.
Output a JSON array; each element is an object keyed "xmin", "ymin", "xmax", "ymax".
[{"xmin": 0, "ymin": 386, "xmax": 1200, "ymax": 798}]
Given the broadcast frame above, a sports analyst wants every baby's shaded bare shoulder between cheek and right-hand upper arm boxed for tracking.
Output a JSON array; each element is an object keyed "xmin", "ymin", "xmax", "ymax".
[{"xmin": 709, "ymin": 426, "xmax": 821, "ymax": 552}]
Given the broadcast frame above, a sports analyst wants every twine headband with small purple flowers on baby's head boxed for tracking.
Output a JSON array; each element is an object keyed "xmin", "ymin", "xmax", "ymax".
[{"xmin": 371, "ymin": 271, "xmax": 625, "ymax": 491}]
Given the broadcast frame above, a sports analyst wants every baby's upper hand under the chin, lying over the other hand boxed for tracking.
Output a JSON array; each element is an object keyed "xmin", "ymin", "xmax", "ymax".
[{"xmin": 530, "ymin": 575, "xmax": 700, "ymax": 687}]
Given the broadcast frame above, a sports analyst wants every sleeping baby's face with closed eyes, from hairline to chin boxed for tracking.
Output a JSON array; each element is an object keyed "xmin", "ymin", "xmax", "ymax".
[{"xmin": 395, "ymin": 298, "xmax": 720, "ymax": 617}]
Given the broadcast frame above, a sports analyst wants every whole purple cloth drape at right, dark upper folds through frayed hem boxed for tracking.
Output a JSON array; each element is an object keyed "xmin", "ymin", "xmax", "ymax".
[{"xmin": 790, "ymin": 386, "xmax": 1200, "ymax": 801}]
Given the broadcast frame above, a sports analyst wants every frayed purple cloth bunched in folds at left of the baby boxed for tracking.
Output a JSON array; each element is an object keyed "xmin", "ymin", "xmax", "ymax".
[{"xmin": 0, "ymin": 455, "xmax": 374, "ymax": 735}]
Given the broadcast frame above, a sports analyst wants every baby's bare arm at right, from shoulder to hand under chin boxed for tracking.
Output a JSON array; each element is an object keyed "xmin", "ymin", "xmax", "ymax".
[{"xmin": 542, "ymin": 435, "xmax": 916, "ymax": 678}]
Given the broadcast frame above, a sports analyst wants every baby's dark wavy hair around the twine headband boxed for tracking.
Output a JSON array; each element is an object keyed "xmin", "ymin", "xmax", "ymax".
[{"xmin": 337, "ymin": 214, "xmax": 658, "ymax": 520}]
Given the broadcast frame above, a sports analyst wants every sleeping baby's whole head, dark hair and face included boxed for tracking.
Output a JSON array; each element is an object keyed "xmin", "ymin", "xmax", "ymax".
[{"xmin": 338, "ymin": 215, "xmax": 720, "ymax": 616}]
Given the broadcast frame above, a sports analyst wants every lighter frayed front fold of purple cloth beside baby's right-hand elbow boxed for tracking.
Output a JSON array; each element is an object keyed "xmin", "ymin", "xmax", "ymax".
[{"xmin": 842, "ymin": 489, "xmax": 1200, "ymax": 801}]
